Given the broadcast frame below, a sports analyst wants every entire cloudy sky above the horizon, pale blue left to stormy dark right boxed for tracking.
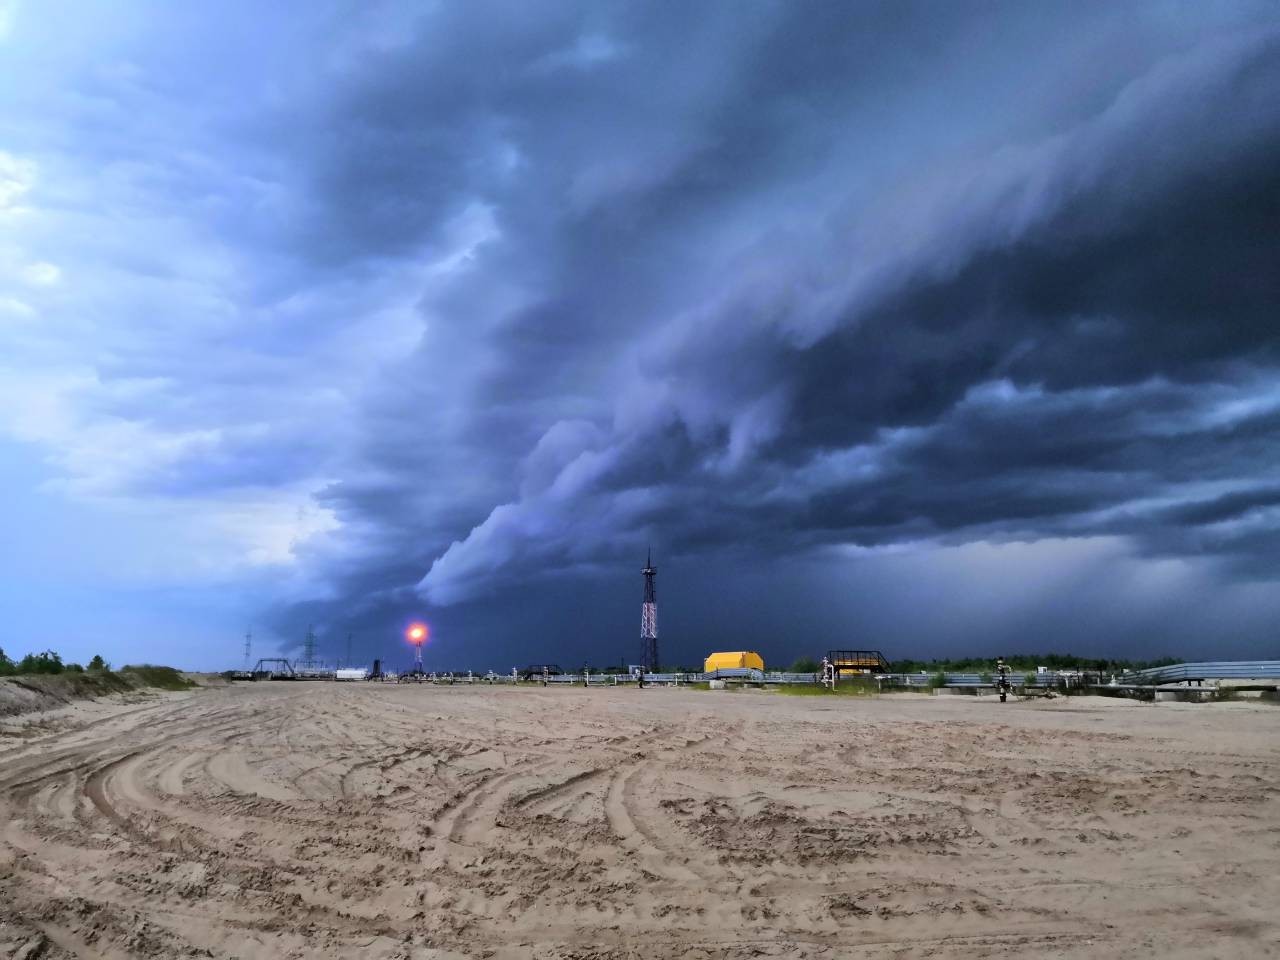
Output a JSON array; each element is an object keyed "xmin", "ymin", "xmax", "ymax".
[{"xmin": 0, "ymin": 0, "xmax": 1280, "ymax": 669}]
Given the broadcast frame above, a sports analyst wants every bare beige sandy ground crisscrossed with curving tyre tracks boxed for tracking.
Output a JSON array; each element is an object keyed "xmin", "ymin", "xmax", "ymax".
[{"xmin": 0, "ymin": 684, "xmax": 1280, "ymax": 960}]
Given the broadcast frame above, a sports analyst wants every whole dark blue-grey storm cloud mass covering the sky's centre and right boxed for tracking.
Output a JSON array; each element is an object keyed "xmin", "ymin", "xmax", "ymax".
[{"xmin": 241, "ymin": 5, "xmax": 1280, "ymax": 670}]
